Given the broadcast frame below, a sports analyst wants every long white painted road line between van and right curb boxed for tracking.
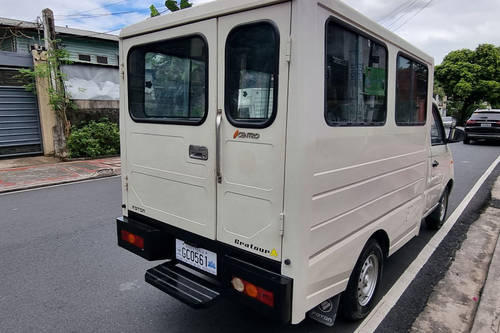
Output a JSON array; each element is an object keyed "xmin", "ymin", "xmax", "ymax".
[{"xmin": 354, "ymin": 155, "xmax": 500, "ymax": 333}]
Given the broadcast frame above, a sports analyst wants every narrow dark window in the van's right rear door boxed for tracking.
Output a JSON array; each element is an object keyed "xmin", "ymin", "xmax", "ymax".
[{"xmin": 225, "ymin": 23, "xmax": 279, "ymax": 127}]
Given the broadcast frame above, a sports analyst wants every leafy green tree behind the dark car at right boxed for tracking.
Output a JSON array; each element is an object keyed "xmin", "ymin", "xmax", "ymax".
[{"xmin": 435, "ymin": 44, "xmax": 500, "ymax": 124}]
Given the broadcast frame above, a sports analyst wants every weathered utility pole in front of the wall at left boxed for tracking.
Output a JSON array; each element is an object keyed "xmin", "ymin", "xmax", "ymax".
[{"xmin": 42, "ymin": 8, "xmax": 69, "ymax": 157}]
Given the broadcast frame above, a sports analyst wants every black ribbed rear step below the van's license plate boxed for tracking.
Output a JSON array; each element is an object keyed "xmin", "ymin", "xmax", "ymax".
[{"xmin": 145, "ymin": 261, "xmax": 222, "ymax": 309}]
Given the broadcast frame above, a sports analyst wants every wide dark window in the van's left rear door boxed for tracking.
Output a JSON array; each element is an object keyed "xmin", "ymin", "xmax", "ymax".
[{"xmin": 128, "ymin": 36, "xmax": 208, "ymax": 125}]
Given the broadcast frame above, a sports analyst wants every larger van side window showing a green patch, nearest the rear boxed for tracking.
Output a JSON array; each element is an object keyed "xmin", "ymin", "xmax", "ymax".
[{"xmin": 325, "ymin": 19, "xmax": 387, "ymax": 126}]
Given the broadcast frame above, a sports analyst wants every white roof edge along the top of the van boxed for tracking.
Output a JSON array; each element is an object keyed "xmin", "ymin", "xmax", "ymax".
[{"xmin": 120, "ymin": 0, "xmax": 434, "ymax": 65}]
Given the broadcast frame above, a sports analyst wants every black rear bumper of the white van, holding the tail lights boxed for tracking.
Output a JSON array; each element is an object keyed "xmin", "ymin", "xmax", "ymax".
[{"xmin": 116, "ymin": 214, "xmax": 293, "ymax": 323}]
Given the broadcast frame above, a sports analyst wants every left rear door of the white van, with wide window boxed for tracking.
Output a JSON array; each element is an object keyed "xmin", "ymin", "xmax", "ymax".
[{"xmin": 122, "ymin": 19, "xmax": 217, "ymax": 239}]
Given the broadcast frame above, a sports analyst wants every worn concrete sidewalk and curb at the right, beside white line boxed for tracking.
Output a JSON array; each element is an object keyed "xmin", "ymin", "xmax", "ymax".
[{"xmin": 410, "ymin": 178, "xmax": 500, "ymax": 333}]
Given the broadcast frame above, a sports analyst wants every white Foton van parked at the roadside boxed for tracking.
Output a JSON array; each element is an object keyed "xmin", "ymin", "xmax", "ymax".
[{"xmin": 117, "ymin": 0, "xmax": 462, "ymax": 324}]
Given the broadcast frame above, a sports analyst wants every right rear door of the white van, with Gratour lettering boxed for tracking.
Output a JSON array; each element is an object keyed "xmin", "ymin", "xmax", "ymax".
[{"xmin": 216, "ymin": 2, "xmax": 291, "ymax": 260}]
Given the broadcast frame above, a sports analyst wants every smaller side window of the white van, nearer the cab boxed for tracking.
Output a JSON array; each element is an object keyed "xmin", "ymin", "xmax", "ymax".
[{"xmin": 396, "ymin": 55, "xmax": 429, "ymax": 126}]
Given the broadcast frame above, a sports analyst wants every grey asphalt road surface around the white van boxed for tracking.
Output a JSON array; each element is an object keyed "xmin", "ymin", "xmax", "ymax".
[{"xmin": 0, "ymin": 143, "xmax": 500, "ymax": 333}]
